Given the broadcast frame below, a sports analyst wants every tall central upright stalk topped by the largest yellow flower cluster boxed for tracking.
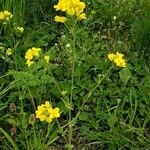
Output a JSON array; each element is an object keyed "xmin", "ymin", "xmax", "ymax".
[{"xmin": 54, "ymin": 0, "xmax": 86, "ymax": 150}]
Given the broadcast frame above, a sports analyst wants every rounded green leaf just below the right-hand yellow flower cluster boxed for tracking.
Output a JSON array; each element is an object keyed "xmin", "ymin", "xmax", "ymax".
[{"xmin": 119, "ymin": 68, "xmax": 131, "ymax": 83}]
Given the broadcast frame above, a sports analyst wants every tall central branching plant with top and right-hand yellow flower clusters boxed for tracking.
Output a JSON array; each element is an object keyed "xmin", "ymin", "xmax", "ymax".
[{"xmin": 47, "ymin": 0, "xmax": 126, "ymax": 150}]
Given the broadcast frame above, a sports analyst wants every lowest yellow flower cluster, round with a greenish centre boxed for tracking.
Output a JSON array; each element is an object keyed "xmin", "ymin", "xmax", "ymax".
[{"xmin": 35, "ymin": 101, "xmax": 60, "ymax": 123}]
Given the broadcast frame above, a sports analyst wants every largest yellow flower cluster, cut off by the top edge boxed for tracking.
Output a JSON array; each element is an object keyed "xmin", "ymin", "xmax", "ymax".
[{"xmin": 54, "ymin": 0, "xmax": 86, "ymax": 23}]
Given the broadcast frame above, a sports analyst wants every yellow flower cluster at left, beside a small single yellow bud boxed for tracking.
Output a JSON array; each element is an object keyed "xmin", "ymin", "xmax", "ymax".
[{"xmin": 25, "ymin": 47, "xmax": 41, "ymax": 67}]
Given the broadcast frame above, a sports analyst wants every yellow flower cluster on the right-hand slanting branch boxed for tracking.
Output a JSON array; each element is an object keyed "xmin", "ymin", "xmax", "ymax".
[{"xmin": 108, "ymin": 52, "xmax": 126, "ymax": 67}]
